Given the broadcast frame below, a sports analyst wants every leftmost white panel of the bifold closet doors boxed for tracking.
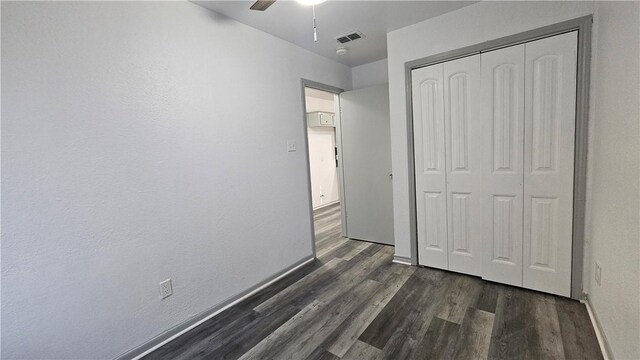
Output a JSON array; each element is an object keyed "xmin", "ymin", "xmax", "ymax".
[{"xmin": 412, "ymin": 64, "xmax": 449, "ymax": 269}]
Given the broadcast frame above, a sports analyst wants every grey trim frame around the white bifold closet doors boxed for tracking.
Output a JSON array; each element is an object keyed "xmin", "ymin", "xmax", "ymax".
[{"xmin": 398, "ymin": 15, "xmax": 593, "ymax": 300}]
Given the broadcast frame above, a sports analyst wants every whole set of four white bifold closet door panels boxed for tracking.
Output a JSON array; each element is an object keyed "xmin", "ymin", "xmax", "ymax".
[{"xmin": 412, "ymin": 32, "xmax": 577, "ymax": 296}]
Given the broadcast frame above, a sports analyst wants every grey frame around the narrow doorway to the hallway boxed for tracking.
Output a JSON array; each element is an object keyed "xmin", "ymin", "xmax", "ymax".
[{"xmin": 300, "ymin": 78, "xmax": 347, "ymax": 258}]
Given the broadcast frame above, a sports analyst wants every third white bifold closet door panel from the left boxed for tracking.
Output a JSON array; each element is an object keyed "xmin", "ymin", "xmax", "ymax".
[{"xmin": 478, "ymin": 45, "xmax": 525, "ymax": 286}]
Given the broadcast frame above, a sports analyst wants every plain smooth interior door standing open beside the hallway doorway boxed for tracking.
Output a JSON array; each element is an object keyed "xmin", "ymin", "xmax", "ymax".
[{"xmin": 340, "ymin": 84, "xmax": 394, "ymax": 245}]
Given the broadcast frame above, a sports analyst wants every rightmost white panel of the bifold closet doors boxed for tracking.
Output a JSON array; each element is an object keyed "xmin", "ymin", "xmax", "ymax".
[{"xmin": 523, "ymin": 32, "xmax": 577, "ymax": 296}]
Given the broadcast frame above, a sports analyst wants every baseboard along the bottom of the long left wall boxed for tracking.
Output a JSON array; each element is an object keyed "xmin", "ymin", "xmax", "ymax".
[{"xmin": 116, "ymin": 255, "xmax": 316, "ymax": 360}]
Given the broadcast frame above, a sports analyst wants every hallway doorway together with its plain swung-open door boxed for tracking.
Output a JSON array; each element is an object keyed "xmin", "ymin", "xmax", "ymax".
[{"xmin": 301, "ymin": 79, "xmax": 394, "ymax": 260}]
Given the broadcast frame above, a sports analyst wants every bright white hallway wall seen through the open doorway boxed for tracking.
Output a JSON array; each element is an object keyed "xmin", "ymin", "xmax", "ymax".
[{"xmin": 306, "ymin": 96, "xmax": 340, "ymax": 208}]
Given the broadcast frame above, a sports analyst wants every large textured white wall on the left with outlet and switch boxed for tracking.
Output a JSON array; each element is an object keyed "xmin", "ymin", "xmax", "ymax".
[{"xmin": 2, "ymin": 2, "xmax": 351, "ymax": 359}]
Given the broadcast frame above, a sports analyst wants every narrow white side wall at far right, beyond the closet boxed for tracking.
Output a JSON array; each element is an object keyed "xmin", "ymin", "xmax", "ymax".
[{"xmin": 585, "ymin": 2, "xmax": 640, "ymax": 359}]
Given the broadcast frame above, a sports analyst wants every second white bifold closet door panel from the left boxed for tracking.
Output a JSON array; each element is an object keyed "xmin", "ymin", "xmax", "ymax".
[{"xmin": 443, "ymin": 55, "xmax": 482, "ymax": 275}]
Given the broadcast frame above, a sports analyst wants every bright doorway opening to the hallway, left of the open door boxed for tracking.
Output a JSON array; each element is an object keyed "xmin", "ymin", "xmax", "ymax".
[{"xmin": 304, "ymin": 86, "xmax": 345, "ymax": 257}]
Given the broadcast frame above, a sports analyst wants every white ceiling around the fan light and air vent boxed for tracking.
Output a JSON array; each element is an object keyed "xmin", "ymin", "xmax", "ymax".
[{"xmin": 194, "ymin": 0, "xmax": 474, "ymax": 66}]
